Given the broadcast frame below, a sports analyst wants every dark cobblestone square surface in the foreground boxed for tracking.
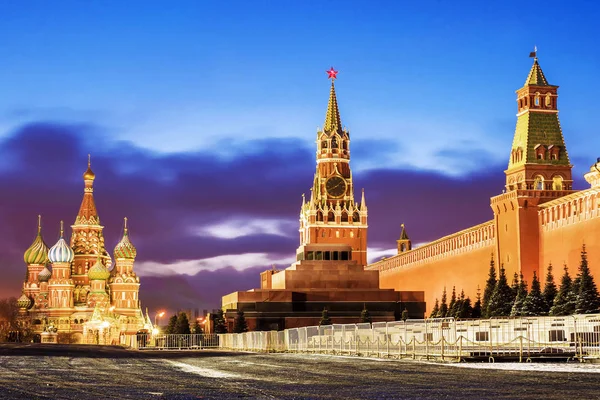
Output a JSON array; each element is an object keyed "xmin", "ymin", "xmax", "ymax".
[{"xmin": 0, "ymin": 345, "xmax": 600, "ymax": 399}]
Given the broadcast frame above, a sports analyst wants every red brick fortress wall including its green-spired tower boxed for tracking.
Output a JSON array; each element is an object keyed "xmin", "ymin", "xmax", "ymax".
[{"xmin": 366, "ymin": 57, "xmax": 600, "ymax": 312}]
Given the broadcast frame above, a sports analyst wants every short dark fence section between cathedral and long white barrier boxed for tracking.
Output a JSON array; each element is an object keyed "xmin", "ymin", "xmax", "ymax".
[{"xmin": 120, "ymin": 334, "xmax": 219, "ymax": 350}]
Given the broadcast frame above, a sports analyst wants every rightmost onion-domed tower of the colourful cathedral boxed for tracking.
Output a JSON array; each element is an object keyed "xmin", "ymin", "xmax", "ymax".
[{"xmin": 109, "ymin": 218, "xmax": 140, "ymax": 315}]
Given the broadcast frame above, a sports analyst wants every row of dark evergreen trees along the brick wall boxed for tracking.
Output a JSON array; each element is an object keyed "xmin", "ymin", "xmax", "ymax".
[{"xmin": 430, "ymin": 245, "xmax": 600, "ymax": 318}]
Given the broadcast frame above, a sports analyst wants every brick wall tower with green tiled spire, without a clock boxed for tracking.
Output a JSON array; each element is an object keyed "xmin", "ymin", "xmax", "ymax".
[{"xmin": 491, "ymin": 52, "xmax": 573, "ymax": 282}]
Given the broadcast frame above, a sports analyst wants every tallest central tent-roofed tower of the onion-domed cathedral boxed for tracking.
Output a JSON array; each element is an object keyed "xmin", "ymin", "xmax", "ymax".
[{"xmin": 71, "ymin": 155, "xmax": 110, "ymax": 306}]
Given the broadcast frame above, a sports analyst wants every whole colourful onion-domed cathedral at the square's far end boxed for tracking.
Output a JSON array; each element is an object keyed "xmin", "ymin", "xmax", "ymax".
[{"xmin": 18, "ymin": 159, "xmax": 151, "ymax": 344}]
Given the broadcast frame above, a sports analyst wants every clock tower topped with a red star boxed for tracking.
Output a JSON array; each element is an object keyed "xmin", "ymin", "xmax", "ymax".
[{"xmin": 300, "ymin": 67, "xmax": 367, "ymax": 265}]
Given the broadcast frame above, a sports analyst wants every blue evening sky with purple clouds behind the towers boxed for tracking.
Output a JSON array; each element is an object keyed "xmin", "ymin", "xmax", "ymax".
[{"xmin": 0, "ymin": 0, "xmax": 600, "ymax": 306}]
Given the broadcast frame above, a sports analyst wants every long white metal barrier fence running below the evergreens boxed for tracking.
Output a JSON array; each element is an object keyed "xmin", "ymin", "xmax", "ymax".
[{"xmin": 219, "ymin": 314, "xmax": 600, "ymax": 361}]
